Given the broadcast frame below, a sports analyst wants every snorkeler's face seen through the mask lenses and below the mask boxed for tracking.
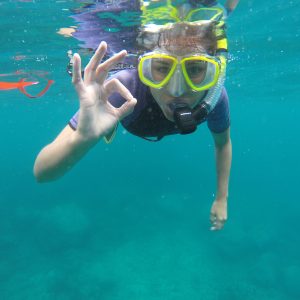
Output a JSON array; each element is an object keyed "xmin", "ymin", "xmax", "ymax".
[{"xmin": 150, "ymin": 51, "xmax": 206, "ymax": 121}]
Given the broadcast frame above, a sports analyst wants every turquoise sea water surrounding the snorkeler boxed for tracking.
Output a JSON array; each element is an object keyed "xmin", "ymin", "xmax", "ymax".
[{"xmin": 0, "ymin": 0, "xmax": 300, "ymax": 300}]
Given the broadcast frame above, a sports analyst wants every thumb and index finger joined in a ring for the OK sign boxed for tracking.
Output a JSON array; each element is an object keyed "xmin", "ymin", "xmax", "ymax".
[{"xmin": 105, "ymin": 79, "xmax": 137, "ymax": 120}]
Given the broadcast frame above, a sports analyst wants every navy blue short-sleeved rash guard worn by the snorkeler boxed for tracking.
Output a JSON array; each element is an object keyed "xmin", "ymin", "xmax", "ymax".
[{"xmin": 69, "ymin": 69, "xmax": 230, "ymax": 139}]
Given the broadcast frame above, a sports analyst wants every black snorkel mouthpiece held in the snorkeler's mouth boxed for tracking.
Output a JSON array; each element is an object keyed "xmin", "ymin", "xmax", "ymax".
[{"xmin": 170, "ymin": 102, "xmax": 209, "ymax": 134}]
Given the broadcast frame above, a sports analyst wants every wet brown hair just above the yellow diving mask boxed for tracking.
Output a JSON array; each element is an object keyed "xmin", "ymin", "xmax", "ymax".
[{"xmin": 137, "ymin": 21, "xmax": 217, "ymax": 55}]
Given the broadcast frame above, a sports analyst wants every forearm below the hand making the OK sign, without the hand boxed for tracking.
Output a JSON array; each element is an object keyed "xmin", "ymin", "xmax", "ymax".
[{"xmin": 34, "ymin": 131, "xmax": 96, "ymax": 182}]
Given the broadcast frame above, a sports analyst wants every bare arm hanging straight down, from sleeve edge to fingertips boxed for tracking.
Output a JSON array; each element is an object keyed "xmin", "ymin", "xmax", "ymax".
[{"xmin": 211, "ymin": 128, "xmax": 232, "ymax": 230}]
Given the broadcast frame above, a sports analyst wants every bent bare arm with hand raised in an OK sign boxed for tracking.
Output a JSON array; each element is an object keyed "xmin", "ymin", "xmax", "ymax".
[{"xmin": 34, "ymin": 43, "xmax": 136, "ymax": 182}]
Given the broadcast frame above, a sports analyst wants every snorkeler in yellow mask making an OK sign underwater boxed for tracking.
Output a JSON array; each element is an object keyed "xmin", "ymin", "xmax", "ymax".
[{"xmin": 34, "ymin": 1, "xmax": 239, "ymax": 230}]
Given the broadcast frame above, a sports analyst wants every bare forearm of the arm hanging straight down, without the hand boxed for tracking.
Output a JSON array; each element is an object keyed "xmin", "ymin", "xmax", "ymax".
[{"xmin": 216, "ymin": 138, "xmax": 232, "ymax": 199}]
